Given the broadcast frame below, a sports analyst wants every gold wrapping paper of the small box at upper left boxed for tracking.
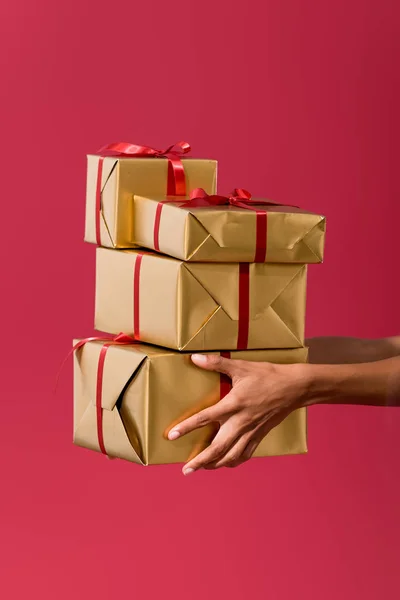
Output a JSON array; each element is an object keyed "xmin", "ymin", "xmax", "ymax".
[{"xmin": 85, "ymin": 155, "xmax": 217, "ymax": 248}]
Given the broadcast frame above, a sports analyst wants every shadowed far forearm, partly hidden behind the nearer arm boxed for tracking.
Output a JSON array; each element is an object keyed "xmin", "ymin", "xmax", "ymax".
[{"xmin": 306, "ymin": 336, "xmax": 400, "ymax": 365}]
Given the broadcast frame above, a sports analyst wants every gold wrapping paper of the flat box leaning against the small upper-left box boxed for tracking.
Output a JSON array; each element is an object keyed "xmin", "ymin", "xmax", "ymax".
[{"xmin": 132, "ymin": 195, "xmax": 325, "ymax": 264}]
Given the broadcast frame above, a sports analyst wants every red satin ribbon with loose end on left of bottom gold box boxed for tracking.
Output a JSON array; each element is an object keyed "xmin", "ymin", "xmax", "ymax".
[{"xmin": 60, "ymin": 333, "xmax": 138, "ymax": 454}]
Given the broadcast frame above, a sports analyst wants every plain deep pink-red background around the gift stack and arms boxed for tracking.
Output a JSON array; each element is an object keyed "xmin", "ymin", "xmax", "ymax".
[{"xmin": 0, "ymin": 0, "xmax": 400, "ymax": 600}]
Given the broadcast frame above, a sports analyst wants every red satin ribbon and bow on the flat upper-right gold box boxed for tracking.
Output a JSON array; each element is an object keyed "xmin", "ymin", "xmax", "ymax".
[{"xmin": 154, "ymin": 188, "xmax": 280, "ymax": 262}]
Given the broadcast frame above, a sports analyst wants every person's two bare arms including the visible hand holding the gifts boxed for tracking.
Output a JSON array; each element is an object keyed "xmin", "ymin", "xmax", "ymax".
[{"xmin": 168, "ymin": 337, "xmax": 400, "ymax": 475}]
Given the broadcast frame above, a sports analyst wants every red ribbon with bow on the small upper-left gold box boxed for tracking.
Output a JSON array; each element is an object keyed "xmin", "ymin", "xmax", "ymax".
[{"xmin": 95, "ymin": 142, "xmax": 191, "ymax": 246}]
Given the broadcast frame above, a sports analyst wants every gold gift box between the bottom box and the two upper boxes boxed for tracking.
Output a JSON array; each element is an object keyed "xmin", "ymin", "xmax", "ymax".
[{"xmin": 95, "ymin": 248, "xmax": 307, "ymax": 351}]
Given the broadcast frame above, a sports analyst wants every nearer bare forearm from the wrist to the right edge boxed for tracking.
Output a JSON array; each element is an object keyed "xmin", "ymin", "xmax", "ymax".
[{"xmin": 303, "ymin": 356, "xmax": 400, "ymax": 406}]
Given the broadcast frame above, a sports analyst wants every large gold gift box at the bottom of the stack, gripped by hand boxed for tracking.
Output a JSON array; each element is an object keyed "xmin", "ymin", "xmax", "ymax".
[{"xmin": 74, "ymin": 339, "xmax": 307, "ymax": 465}]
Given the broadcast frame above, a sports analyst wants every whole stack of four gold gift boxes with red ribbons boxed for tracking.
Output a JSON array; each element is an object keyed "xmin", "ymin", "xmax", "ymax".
[{"xmin": 74, "ymin": 145, "xmax": 325, "ymax": 465}]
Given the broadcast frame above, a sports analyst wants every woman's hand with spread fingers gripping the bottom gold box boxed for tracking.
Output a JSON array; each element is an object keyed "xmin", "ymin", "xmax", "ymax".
[{"xmin": 168, "ymin": 354, "xmax": 310, "ymax": 475}]
